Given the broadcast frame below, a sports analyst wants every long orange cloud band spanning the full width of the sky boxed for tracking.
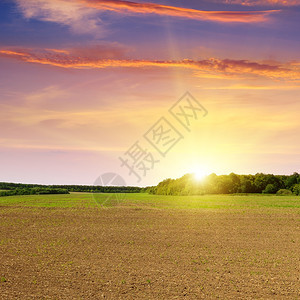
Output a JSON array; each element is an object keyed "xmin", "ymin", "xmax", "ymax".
[{"xmin": 0, "ymin": 47, "xmax": 300, "ymax": 80}]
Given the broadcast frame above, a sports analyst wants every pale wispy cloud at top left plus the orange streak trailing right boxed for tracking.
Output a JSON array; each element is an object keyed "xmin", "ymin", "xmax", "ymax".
[{"xmin": 15, "ymin": 0, "xmax": 276, "ymax": 31}]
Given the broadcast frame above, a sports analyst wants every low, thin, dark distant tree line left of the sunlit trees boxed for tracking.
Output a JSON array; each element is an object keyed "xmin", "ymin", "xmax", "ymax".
[{"xmin": 0, "ymin": 182, "xmax": 145, "ymax": 196}]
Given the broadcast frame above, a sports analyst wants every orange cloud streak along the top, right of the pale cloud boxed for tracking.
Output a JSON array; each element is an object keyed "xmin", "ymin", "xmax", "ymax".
[{"xmin": 78, "ymin": 0, "xmax": 276, "ymax": 23}]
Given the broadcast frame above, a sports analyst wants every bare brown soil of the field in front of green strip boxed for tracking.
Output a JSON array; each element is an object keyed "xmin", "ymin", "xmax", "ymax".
[{"xmin": 0, "ymin": 207, "xmax": 300, "ymax": 299}]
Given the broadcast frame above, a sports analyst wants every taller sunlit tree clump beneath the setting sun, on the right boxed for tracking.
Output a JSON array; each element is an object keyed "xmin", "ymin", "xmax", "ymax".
[{"xmin": 147, "ymin": 173, "xmax": 300, "ymax": 195}]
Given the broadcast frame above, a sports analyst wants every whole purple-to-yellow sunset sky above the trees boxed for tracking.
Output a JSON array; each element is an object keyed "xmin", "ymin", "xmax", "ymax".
[{"xmin": 0, "ymin": 0, "xmax": 300, "ymax": 186}]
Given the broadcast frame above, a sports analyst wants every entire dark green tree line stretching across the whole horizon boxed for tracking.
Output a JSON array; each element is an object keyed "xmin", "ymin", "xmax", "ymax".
[{"xmin": 0, "ymin": 173, "xmax": 300, "ymax": 196}]
